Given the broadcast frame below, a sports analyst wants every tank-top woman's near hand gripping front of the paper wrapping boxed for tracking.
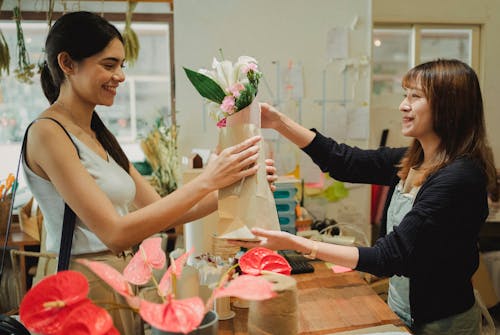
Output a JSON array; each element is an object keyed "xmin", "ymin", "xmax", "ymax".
[{"xmin": 200, "ymin": 136, "xmax": 262, "ymax": 191}]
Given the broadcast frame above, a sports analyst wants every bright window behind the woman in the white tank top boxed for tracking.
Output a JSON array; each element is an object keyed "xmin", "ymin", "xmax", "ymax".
[{"xmin": 0, "ymin": 21, "xmax": 171, "ymax": 144}]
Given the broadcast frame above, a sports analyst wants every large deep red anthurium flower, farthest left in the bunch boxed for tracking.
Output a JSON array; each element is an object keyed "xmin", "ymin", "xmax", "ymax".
[{"xmin": 19, "ymin": 270, "xmax": 90, "ymax": 335}]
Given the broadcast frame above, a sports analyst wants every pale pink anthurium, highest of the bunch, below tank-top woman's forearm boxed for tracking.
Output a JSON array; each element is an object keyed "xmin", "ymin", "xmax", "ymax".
[{"xmin": 123, "ymin": 237, "xmax": 166, "ymax": 285}]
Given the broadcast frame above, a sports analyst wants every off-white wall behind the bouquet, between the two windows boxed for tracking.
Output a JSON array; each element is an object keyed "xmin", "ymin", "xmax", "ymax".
[{"xmin": 174, "ymin": 0, "xmax": 372, "ymax": 234}]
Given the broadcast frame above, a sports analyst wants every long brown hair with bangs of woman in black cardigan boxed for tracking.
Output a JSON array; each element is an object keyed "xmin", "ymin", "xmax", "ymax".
[{"xmin": 398, "ymin": 59, "xmax": 498, "ymax": 198}]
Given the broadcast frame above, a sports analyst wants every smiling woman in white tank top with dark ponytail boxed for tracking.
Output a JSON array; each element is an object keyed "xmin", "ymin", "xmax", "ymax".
[{"xmin": 23, "ymin": 12, "xmax": 275, "ymax": 334}]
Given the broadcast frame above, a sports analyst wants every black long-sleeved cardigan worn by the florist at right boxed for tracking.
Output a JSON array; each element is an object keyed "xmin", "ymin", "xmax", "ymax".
[{"xmin": 303, "ymin": 129, "xmax": 488, "ymax": 326}]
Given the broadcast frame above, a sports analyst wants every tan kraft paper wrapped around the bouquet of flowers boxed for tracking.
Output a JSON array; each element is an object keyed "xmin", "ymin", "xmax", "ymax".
[{"xmin": 217, "ymin": 100, "xmax": 280, "ymax": 240}]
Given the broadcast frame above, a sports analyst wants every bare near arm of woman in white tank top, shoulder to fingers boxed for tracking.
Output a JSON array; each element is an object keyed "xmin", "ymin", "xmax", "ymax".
[{"xmin": 27, "ymin": 121, "xmax": 260, "ymax": 255}]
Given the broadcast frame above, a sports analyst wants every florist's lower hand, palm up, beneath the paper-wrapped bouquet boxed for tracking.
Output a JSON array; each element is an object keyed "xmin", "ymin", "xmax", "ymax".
[{"xmin": 229, "ymin": 228, "xmax": 300, "ymax": 250}]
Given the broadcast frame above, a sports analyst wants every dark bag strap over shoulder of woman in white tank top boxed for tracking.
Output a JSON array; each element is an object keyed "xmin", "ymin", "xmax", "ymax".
[{"xmin": 0, "ymin": 117, "xmax": 80, "ymax": 279}]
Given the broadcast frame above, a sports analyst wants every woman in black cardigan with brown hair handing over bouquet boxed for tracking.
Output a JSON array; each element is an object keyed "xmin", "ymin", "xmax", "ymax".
[{"xmin": 233, "ymin": 60, "xmax": 498, "ymax": 335}]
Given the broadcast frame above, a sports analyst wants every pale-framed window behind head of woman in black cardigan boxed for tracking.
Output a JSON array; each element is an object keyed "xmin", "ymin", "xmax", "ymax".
[{"xmin": 370, "ymin": 23, "xmax": 480, "ymax": 146}]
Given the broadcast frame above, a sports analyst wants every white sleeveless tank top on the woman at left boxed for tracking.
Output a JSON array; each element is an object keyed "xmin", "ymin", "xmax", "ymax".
[{"xmin": 23, "ymin": 129, "xmax": 135, "ymax": 255}]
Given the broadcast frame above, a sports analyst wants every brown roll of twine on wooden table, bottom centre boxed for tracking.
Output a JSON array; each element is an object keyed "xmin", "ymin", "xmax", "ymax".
[{"xmin": 248, "ymin": 273, "xmax": 299, "ymax": 335}]
